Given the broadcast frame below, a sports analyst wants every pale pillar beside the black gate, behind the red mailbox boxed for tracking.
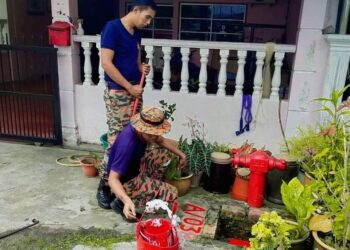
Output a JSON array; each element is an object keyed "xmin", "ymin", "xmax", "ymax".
[{"xmin": 51, "ymin": 0, "xmax": 81, "ymax": 145}]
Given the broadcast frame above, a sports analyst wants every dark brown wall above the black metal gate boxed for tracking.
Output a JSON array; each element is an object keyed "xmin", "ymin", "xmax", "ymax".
[{"xmin": 7, "ymin": 0, "xmax": 52, "ymax": 45}]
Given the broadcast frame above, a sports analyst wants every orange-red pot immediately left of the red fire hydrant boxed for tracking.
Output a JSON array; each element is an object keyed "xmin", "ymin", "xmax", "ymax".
[{"xmin": 231, "ymin": 168, "xmax": 250, "ymax": 201}]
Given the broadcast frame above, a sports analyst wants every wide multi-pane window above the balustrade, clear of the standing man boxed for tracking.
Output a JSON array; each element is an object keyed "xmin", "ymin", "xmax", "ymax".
[{"xmin": 180, "ymin": 3, "xmax": 246, "ymax": 42}]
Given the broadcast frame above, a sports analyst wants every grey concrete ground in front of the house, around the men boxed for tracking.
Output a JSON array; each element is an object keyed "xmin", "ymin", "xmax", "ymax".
[{"xmin": 0, "ymin": 141, "xmax": 270, "ymax": 250}]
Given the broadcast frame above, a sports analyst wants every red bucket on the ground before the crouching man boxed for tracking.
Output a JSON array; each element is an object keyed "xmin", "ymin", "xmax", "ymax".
[{"xmin": 136, "ymin": 219, "xmax": 179, "ymax": 250}]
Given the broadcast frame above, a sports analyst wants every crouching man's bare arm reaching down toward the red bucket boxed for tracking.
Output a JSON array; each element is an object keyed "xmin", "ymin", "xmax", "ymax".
[{"xmin": 108, "ymin": 170, "xmax": 136, "ymax": 219}]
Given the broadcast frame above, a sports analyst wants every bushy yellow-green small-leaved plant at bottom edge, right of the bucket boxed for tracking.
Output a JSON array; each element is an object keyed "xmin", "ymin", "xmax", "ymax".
[{"xmin": 248, "ymin": 211, "xmax": 291, "ymax": 250}]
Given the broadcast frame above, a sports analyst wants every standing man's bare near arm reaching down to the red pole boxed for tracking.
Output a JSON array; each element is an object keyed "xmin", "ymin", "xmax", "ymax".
[{"xmin": 101, "ymin": 48, "xmax": 142, "ymax": 97}]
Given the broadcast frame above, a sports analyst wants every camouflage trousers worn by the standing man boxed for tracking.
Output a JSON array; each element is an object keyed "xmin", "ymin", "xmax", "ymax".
[{"xmin": 99, "ymin": 88, "xmax": 142, "ymax": 179}]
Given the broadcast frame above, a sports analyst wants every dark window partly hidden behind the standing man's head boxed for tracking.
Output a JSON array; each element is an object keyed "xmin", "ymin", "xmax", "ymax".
[{"xmin": 126, "ymin": 4, "xmax": 173, "ymax": 39}]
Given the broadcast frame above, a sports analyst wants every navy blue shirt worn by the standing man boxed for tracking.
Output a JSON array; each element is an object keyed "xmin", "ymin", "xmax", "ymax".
[{"xmin": 101, "ymin": 19, "xmax": 141, "ymax": 89}]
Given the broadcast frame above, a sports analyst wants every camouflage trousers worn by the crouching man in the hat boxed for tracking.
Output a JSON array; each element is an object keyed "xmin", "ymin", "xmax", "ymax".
[{"xmin": 123, "ymin": 144, "xmax": 177, "ymax": 213}]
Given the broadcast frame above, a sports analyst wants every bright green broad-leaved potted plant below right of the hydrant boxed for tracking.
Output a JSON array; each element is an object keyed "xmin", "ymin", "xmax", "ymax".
[{"xmin": 281, "ymin": 177, "xmax": 315, "ymax": 240}]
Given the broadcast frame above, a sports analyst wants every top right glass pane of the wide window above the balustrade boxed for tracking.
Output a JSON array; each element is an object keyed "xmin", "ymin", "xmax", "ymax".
[{"xmin": 213, "ymin": 4, "xmax": 245, "ymax": 20}]
